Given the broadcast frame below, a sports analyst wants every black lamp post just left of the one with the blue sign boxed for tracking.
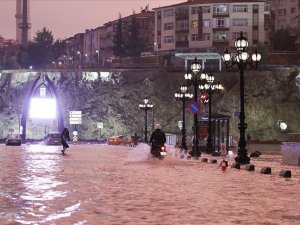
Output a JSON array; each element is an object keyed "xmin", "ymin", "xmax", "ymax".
[{"xmin": 175, "ymin": 85, "xmax": 193, "ymax": 150}]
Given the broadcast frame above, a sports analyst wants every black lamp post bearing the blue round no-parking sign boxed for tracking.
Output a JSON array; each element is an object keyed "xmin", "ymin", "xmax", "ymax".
[{"xmin": 184, "ymin": 58, "xmax": 207, "ymax": 157}]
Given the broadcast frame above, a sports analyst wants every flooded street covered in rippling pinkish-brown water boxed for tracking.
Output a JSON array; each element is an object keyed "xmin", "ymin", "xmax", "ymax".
[{"xmin": 0, "ymin": 144, "xmax": 300, "ymax": 225}]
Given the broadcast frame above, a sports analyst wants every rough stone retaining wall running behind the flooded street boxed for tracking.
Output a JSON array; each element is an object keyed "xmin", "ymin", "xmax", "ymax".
[{"xmin": 0, "ymin": 69, "xmax": 300, "ymax": 140}]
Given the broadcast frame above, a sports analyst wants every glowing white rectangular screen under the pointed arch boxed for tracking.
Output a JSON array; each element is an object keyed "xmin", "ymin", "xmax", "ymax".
[{"xmin": 29, "ymin": 98, "xmax": 56, "ymax": 119}]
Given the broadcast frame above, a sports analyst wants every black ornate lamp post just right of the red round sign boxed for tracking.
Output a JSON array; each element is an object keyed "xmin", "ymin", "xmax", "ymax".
[{"xmin": 199, "ymin": 74, "xmax": 223, "ymax": 154}]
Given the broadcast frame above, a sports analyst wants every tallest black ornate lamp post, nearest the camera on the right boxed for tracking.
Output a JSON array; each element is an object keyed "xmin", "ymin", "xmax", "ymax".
[{"xmin": 222, "ymin": 31, "xmax": 261, "ymax": 164}]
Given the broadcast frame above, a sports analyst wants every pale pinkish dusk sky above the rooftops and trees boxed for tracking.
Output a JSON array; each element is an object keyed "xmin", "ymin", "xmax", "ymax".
[{"xmin": 0, "ymin": 0, "xmax": 186, "ymax": 39}]
